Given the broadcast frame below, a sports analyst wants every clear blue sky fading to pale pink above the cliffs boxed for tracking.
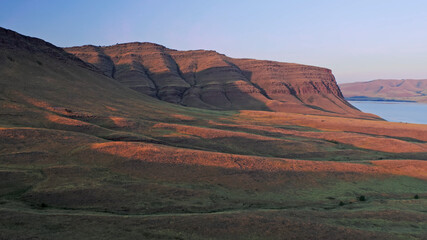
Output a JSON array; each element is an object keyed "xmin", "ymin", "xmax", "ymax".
[{"xmin": 0, "ymin": 0, "xmax": 427, "ymax": 83}]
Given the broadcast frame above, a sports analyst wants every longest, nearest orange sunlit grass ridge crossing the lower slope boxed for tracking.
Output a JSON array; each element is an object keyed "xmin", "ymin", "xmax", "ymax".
[{"xmin": 91, "ymin": 142, "xmax": 427, "ymax": 180}]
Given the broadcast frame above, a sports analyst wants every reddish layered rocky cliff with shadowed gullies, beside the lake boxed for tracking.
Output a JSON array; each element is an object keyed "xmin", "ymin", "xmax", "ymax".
[{"xmin": 65, "ymin": 42, "xmax": 372, "ymax": 118}]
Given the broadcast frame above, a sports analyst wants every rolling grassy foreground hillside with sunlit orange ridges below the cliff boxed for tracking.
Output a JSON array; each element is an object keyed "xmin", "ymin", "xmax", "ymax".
[{"xmin": 0, "ymin": 28, "xmax": 427, "ymax": 239}]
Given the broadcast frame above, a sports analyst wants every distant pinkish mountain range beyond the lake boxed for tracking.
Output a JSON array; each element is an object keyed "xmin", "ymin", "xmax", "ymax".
[{"xmin": 339, "ymin": 79, "xmax": 427, "ymax": 102}]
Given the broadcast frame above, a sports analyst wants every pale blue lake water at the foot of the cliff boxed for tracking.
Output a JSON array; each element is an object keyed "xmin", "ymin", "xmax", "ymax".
[{"xmin": 349, "ymin": 101, "xmax": 427, "ymax": 124}]
